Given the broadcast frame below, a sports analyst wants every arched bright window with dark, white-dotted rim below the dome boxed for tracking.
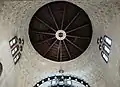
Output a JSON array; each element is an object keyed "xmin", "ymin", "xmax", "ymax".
[{"xmin": 34, "ymin": 75, "xmax": 90, "ymax": 87}]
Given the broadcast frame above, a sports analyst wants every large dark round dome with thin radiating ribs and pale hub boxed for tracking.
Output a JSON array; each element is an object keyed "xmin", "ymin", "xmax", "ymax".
[{"xmin": 29, "ymin": 1, "xmax": 92, "ymax": 62}]
